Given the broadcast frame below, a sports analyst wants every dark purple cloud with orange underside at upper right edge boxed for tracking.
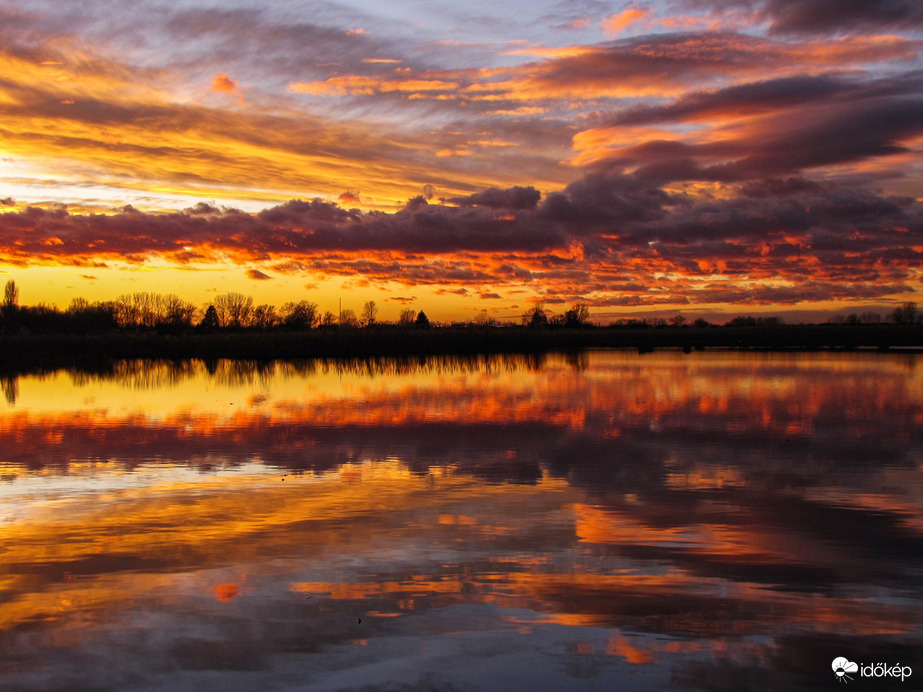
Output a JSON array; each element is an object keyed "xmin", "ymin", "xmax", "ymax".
[{"xmin": 592, "ymin": 72, "xmax": 923, "ymax": 184}]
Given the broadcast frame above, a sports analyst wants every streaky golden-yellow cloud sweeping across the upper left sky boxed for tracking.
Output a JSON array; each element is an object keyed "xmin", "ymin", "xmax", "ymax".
[{"xmin": 0, "ymin": 36, "xmax": 569, "ymax": 207}]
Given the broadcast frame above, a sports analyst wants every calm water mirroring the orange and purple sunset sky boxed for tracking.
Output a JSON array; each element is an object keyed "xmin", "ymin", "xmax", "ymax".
[{"xmin": 0, "ymin": 352, "xmax": 923, "ymax": 692}]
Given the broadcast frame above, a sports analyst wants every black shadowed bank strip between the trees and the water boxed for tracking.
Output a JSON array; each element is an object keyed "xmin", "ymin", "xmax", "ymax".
[{"xmin": 0, "ymin": 325, "xmax": 923, "ymax": 371}]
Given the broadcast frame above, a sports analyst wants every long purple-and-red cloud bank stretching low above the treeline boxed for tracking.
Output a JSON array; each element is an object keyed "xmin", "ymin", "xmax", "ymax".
[{"xmin": 0, "ymin": 168, "xmax": 923, "ymax": 306}]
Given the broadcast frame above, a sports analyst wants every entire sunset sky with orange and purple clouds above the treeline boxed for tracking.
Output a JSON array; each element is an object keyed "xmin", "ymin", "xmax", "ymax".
[{"xmin": 0, "ymin": 0, "xmax": 923, "ymax": 322}]
